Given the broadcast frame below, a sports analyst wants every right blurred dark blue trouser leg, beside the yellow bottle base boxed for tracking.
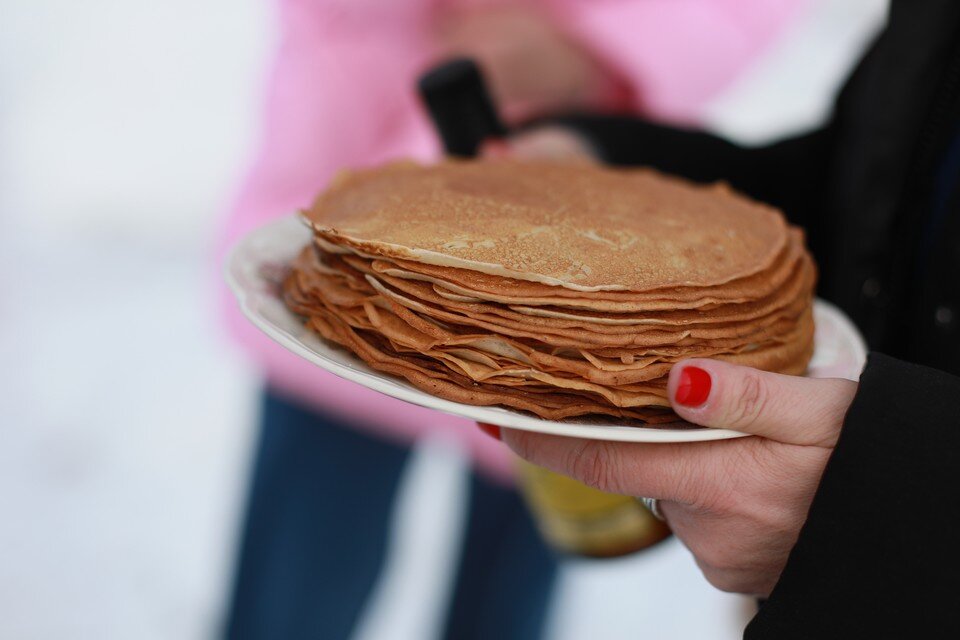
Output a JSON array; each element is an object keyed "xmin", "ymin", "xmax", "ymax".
[{"xmin": 444, "ymin": 468, "xmax": 557, "ymax": 640}]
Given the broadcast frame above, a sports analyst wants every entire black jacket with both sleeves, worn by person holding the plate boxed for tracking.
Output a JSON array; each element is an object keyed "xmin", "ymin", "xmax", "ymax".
[{"xmin": 563, "ymin": 0, "xmax": 960, "ymax": 639}]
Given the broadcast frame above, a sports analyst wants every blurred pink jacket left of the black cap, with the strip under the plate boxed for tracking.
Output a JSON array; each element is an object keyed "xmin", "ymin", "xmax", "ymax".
[{"xmin": 215, "ymin": 0, "xmax": 513, "ymax": 482}]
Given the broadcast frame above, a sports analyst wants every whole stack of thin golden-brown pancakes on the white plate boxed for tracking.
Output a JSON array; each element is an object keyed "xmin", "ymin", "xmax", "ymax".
[{"xmin": 284, "ymin": 161, "xmax": 816, "ymax": 424}]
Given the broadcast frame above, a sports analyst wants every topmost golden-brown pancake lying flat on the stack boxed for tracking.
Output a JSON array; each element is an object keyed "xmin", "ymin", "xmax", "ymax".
[{"xmin": 304, "ymin": 161, "xmax": 788, "ymax": 292}]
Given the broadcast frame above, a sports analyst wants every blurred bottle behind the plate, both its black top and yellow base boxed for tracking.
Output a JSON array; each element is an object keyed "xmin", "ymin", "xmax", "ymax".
[{"xmin": 419, "ymin": 58, "xmax": 670, "ymax": 558}]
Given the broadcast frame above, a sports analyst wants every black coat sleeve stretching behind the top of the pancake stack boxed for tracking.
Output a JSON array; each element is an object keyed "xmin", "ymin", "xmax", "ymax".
[{"xmin": 551, "ymin": 115, "xmax": 833, "ymax": 233}]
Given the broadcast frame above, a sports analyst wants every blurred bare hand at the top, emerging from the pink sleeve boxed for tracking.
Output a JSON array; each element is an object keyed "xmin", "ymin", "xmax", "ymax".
[{"xmin": 434, "ymin": 3, "xmax": 625, "ymax": 124}]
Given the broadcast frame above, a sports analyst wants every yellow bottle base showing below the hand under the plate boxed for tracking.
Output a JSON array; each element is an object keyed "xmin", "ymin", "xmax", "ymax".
[{"xmin": 520, "ymin": 460, "xmax": 670, "ymax": 558}]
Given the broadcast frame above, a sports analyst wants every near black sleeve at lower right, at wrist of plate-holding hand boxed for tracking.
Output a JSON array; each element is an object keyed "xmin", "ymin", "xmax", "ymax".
[{"xmin": 745, "ymin": 354, "xmax": 960, "ymax": 640}]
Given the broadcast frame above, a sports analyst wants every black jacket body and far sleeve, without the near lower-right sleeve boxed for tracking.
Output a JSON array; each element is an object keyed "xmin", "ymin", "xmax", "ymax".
[{"xmin": 553, "ymin": 0, "xmax": 960, "ymax": 373}]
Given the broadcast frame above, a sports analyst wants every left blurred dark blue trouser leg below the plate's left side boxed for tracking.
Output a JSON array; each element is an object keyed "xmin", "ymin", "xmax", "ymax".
[{"xmin": 226, "ymin": 392, "xmax": 408, "ymax": 640}]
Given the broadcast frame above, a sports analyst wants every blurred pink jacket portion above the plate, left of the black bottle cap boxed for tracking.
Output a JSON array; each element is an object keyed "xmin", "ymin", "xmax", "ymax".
[{"xmin": 217, "ymin": 0, "xmax": 438, "ymax": 255}]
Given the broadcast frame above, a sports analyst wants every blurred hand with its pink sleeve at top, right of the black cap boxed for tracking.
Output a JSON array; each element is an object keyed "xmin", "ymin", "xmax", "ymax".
[{"xmin": 435, "ymin": 0, "xmax": 808, "ymax": 123}]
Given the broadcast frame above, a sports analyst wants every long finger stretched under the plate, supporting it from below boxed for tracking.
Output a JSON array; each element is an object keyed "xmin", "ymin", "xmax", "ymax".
[{"xmin": 501, "ymin": 429, "xmax": 733, "ymax": 504}]
